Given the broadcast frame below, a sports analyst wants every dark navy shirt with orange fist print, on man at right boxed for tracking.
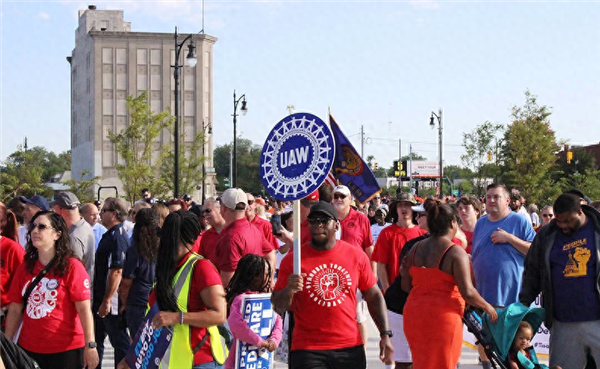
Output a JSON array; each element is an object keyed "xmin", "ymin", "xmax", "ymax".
[{"xmin": 550, "ymin": 220, "xmax": 600, "ymax": 322}]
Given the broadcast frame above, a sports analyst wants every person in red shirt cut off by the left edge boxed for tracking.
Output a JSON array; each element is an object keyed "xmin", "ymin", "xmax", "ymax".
[{"xmin": 0, "ymin": 202, "xmax": 25, "ymax": 310}]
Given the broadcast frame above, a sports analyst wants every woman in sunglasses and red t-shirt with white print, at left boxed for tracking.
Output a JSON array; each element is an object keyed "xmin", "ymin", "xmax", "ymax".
[{"xmin": 6, "ymin": 211, "xmax": 99, "ymax": 369}]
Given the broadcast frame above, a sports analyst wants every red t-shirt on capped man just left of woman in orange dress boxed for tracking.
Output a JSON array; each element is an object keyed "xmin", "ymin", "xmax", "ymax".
[{"xmin": 371, "ymin": 223, "xmax": 427, "ymax": 284}]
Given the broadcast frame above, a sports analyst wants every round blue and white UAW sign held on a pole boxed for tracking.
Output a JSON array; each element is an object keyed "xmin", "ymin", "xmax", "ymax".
[{"xmin": 260, "ymin": 113, "xmax": 335, "ymax": 201}]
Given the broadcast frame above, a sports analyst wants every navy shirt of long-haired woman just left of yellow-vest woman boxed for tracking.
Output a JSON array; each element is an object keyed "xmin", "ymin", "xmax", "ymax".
[{"xmin": 123, "ymin": 245, "xmax": 156, "ymax": 307}]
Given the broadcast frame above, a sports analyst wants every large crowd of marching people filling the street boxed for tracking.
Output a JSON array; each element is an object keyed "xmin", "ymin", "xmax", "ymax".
[{"xmin": 0, "ymin": 184, "xmax": 600, "ymax": 369}]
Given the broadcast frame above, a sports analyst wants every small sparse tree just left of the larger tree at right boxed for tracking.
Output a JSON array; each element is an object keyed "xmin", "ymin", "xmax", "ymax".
[{"xmin": 460, "ymin": 121, "xmax": 504, "ymax": 195}]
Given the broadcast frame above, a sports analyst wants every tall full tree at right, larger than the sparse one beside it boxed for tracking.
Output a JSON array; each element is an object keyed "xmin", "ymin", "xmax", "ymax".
[{"xmin": 502, "ymin": 90, "xmax": 558, "ymax": 203}]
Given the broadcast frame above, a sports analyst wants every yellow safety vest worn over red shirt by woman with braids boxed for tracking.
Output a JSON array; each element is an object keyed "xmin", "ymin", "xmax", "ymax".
[{"xmin": 160, "ymin": 253, "xmax": 229, "ymax": 369}]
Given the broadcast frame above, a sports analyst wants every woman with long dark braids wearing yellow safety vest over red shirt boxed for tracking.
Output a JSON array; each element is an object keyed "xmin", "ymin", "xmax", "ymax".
[{"xmin": 135, "ymin": 210, "xmax": 227, "ymax": 369}]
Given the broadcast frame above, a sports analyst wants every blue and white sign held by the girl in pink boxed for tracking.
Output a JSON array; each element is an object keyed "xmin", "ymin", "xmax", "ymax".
[{"xmin": 235, "ymin": 293, "xmax": 275, "ymax": 369}]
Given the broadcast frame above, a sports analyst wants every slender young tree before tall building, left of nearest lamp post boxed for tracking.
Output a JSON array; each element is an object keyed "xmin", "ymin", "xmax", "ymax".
[{"xmin": 109, "ymin": 92, "xmax": 174, "ymax": 203}]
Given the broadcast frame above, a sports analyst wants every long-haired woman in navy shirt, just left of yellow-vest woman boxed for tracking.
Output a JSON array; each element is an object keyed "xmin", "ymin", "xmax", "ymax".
[{"xmin": 119, "ymin": 208, "xmax": 159, "ymax": 336}]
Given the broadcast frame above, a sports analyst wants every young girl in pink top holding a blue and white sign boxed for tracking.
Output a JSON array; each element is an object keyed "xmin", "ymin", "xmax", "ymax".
[{"xmin": 225, "ymin": 254, "xmax": 283, "ymax": 369}]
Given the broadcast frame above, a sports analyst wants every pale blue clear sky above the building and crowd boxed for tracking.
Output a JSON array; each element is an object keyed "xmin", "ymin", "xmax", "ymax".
[{"xmin": 0, "ymin": 0, "xmax": 600, "ymax": 167}]
